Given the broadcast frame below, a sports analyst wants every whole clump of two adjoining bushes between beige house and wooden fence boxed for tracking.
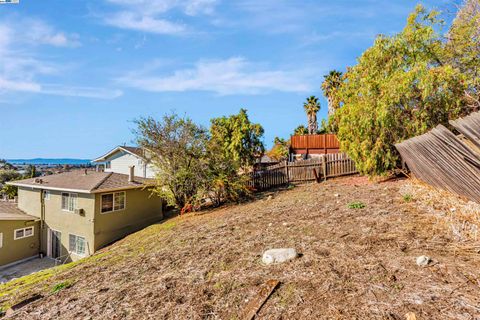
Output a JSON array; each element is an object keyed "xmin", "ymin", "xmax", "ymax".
[{"xmin": 135, "ymin": 109, "xmax": 264, "ymax": 212}]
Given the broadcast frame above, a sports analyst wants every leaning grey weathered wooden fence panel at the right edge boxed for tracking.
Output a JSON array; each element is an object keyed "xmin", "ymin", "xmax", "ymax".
[{"xmin": 395, "ymin": 125, "xmax": 480, "ymax": 202}]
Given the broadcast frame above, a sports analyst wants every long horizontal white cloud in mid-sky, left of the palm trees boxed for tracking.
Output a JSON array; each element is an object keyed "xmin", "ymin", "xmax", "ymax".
[{"xmin": 118, "ymin": 57, "xmax": 313, "ymax": 95}]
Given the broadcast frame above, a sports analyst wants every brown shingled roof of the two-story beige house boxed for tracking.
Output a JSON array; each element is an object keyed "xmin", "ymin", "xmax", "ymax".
[{"xmin": 7, "ymin": 170, "xmax": 155, "ymax": 193}]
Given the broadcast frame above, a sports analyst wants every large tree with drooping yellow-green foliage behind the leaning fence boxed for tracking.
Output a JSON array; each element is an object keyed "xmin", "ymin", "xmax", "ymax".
[{"xmin": 338, "ymin": 6, "xmax": 468, "ymax": 175}]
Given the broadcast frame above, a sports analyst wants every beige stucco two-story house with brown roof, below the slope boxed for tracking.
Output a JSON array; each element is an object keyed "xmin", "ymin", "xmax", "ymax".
[{"xmin": 0, "ymin": 168, "xmax": 163, "ymax": 266}]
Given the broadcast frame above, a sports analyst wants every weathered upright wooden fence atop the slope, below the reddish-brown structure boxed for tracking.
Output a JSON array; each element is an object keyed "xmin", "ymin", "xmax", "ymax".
[{"xmin": 249, "ymin": 153, "xmax": 357, "ymax": 190}]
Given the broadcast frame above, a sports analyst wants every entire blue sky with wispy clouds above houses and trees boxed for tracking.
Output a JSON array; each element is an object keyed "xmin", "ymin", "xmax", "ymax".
[{"xmin": 0, "ymin": 0, "xmax": 458, "ymax": 159}]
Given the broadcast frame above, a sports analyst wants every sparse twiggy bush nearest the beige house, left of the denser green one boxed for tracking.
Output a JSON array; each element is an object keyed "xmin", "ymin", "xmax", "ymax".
[{"xmin": 136, "ymin": 114, "xmax": 208, "ymax": 208}]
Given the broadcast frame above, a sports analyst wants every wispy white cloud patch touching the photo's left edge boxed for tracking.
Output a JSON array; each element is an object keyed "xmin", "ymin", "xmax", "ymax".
[{"xmin": 0, "ymin": 19, "xmax": 123, "ymax": 102}]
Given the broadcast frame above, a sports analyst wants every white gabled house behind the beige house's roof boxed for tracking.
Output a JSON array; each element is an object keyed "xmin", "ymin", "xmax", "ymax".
[{"xmin": 92, "ymin": 146, "xmax": 155, "ymax": 178}]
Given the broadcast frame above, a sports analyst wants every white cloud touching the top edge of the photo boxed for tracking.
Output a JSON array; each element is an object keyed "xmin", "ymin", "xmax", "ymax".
[{"xmin": 103, "ymin": 0, "xmax": 218, "ymax": 35}]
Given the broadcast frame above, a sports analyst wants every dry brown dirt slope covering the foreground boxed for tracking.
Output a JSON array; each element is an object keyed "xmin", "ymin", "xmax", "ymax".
[{"xmin": 0, "ymin": 178, "xmax": 480, "ymax": 319}]
